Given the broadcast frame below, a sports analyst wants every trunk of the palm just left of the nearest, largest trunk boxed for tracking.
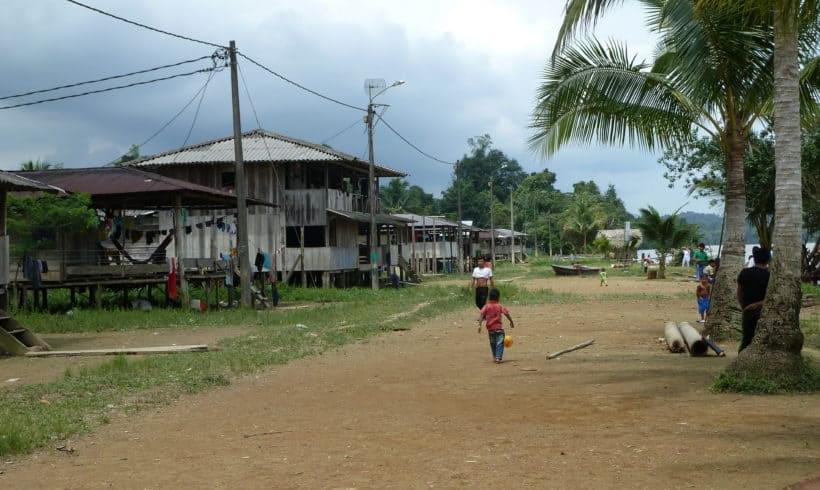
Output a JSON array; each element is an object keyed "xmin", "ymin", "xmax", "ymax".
[{"xmin": 705, "ymin": 128, "xmax": 746, "ymax": 338}]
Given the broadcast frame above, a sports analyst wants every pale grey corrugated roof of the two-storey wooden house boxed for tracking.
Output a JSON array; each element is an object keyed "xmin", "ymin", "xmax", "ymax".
[{"xmin": 129, "ymin": 129, "xmax": 407, "ymax": 177}]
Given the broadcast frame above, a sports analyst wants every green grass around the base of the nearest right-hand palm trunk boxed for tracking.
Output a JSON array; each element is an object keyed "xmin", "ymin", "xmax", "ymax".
[{"xmin": 712, "ymin": 359, "xmax": 820, "ymax": 395}]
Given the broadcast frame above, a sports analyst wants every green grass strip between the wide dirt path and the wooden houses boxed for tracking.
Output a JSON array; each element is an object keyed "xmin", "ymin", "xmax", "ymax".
[{"xmin": 0, "ymin": 285, "xmax": 566, "ymax": 455}]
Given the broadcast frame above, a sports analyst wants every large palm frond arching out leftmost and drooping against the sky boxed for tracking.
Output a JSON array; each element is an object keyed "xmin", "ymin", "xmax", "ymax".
[{"xmin": 530, "ymin": 38, "xmax": 700, "ymax": 155}]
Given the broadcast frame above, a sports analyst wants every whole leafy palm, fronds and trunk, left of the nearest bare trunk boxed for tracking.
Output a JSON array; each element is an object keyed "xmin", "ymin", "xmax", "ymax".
[{"xmin": 531, "ymin": 0, "xmax": 820, "ymax": 335}]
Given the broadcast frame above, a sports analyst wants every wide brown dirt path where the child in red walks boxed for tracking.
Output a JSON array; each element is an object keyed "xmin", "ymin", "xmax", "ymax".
[{"xmin": 0, "ymin": 279, "xmax": 820, "ymax": 489}]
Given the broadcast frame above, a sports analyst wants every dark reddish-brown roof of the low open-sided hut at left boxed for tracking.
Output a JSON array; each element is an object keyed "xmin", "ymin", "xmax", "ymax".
[{"xmin": 17, "ymin": 167, "xmax": 270, "ymax": 209}]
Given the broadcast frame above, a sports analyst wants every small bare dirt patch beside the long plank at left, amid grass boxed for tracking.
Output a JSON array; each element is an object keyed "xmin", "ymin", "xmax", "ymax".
[{"xmin": 0, "ymin": 327, "xmax": 251, "ymax": 390}]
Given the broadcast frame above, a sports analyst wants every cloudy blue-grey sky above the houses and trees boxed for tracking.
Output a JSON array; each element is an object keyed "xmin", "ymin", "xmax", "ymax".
[{"xmin": 0, "ymin": 0, "xmax": 710, "ymax": 211}]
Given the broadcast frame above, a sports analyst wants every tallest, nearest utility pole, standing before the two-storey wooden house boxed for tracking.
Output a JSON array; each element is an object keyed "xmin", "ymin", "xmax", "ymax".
[{"xmin": 228, "ymin": 41, "xmax": 251, "ymax": 308}]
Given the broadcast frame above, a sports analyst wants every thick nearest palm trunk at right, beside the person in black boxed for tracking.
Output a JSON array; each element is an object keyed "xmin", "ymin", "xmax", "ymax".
[{"xmin": 729, "ymin": 0, "xmax": 803, "ymax": 378}]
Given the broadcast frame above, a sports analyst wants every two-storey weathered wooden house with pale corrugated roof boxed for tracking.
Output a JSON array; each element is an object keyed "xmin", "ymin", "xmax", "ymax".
[{"xmin": 131, "ymin": 130, "xmax": 406, "ymax": 287}]
